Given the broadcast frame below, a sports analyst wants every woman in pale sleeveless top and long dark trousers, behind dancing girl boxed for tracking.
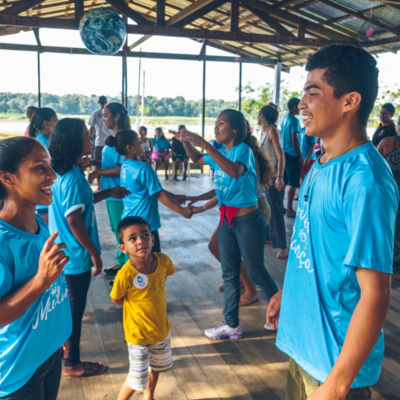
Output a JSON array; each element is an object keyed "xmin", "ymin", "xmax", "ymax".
[{"xmin": 257, "ymin": 103, "xmax": 288, "ymax": 259}]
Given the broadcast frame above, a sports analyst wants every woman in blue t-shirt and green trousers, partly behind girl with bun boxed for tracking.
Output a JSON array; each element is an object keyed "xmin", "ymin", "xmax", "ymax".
[{"xmin": 88, "ymin": 103, "xmax": 131, "ymax": 275}]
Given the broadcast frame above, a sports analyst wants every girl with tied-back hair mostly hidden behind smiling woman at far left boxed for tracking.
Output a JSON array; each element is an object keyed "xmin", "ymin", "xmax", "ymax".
[{"xmin": 29, "ymin": 107, "xmax": 58, "ymax": 224}]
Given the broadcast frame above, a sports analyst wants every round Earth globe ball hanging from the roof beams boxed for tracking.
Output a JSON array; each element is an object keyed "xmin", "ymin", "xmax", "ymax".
[{"xmin": 79, "ymin": 7, "xmax": 127, "ymax": 55}]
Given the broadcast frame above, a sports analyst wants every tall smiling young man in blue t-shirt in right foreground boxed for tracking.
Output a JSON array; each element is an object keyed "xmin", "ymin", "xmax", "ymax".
[{"xmin": 266, "ymin": 45, "xmax": 399, "ymax": 400}]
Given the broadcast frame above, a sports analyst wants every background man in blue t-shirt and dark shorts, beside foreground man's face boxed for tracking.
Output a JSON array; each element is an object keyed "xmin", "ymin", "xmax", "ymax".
[{"xmin": 281, "ymin": 97, "xmax": 303, "ymax": 218}]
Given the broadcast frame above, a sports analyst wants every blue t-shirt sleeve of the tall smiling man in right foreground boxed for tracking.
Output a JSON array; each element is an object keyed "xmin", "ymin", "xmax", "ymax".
[{"xmin": 344, "ymin": 174, "xmax": 399, "ymax": 273}]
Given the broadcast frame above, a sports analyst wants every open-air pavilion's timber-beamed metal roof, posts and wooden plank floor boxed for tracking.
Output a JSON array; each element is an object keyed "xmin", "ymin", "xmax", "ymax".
[{"xmin": 0, "ymin": 0, "xmax": 400, "ymax": 400}]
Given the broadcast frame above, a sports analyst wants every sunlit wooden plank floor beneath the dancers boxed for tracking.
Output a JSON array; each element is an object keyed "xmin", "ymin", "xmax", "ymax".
[{"xmin": 58, "ymin": 175, "xmax": 400, "ymax": 400}]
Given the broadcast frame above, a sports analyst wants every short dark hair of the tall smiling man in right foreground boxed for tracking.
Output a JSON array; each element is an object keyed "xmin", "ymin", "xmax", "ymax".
[{"xmin": 306, "ymin": 45, "xmax": 379, "ymax": 126}]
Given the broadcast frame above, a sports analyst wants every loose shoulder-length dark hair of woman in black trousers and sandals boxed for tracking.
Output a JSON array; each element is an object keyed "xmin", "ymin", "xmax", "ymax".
[{"xmin": 49, "ymin": 118, "xmax": 85, "ymax": 175}]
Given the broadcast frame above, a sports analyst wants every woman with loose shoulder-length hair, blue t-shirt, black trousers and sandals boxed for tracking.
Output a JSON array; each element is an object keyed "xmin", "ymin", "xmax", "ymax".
[{"xmin": 49, "ymin": 118, "xmax": 127, "ymax": 377}]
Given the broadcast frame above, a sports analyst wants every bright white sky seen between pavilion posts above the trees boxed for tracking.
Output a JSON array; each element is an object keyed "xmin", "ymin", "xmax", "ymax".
[{"xmin": 0, "ymin": 28, "xmax": 400, "ymax": 101}]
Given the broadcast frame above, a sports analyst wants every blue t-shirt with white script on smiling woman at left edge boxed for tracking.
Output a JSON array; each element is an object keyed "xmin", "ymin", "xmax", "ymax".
[{"xmin": 0, "ymin": 216, "xmax": 72, "ymax": 397}]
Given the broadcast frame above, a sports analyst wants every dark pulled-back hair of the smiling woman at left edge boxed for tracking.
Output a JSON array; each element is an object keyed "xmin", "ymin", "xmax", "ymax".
[{"xmin": 0, "ymin": 136, "xmax": 42, "ymax": 208}]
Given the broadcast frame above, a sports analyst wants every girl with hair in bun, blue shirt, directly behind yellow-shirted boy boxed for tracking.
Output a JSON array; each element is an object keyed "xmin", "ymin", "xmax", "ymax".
[{"xmin": 110, "ymin": 130, "xmax": 192, "ymax": 252}]
